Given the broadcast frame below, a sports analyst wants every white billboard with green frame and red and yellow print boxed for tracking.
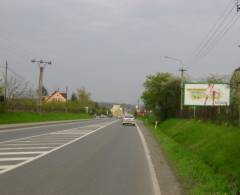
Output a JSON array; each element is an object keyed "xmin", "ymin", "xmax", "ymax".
[{"xmin": 184, "ymin": 83, "xmax": 230, "ymax": 106}]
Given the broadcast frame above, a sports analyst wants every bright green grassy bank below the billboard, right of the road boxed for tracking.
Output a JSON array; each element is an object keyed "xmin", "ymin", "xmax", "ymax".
[{"xmin": 142, "ymin": 119, "xmax": 240, "ymax": 195}]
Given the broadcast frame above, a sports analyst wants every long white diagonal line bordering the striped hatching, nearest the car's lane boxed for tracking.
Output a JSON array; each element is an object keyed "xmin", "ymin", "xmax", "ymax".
[{"xmin": 0, "ymin": 121, "xmax": 118, "ymax": 174}]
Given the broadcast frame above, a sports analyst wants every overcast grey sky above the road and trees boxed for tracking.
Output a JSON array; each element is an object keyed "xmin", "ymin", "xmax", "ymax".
[{"xmin": 0, "ymin": 0, "xmax": 240, "ymax": 104}]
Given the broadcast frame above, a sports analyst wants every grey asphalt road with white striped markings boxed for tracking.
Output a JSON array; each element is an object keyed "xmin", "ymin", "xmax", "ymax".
[{"xmin": 0, "ymin": 120, "xmax": 156, "ymax": 195}]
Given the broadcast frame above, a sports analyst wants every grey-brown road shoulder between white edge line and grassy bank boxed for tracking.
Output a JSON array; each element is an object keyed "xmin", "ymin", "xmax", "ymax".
[{"xmin": 138, "ymin": 121, "xmax": 181, "ymax": 195}]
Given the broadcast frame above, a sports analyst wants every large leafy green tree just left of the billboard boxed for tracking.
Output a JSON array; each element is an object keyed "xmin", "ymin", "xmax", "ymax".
[{"xmin": 142, "ymin": 73, "xmax": 181, "ymax": 120}]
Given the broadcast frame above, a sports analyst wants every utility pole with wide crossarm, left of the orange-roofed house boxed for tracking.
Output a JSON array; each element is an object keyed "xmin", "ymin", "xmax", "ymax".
[{"xmin": 31, "ymin": 59, "xmax": 52, "ymax": 113}]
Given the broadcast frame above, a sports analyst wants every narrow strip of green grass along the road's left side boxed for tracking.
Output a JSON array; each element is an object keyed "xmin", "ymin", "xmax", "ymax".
[{"xmin": 0, "ymin": 112, "xmax": 92, "ymax": 124}]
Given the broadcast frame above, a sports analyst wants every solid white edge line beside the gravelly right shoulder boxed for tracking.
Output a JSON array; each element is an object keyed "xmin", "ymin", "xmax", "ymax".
[{"xmin": 136, "ymin": 123, "xmax": 161, "ymax": 195}]
